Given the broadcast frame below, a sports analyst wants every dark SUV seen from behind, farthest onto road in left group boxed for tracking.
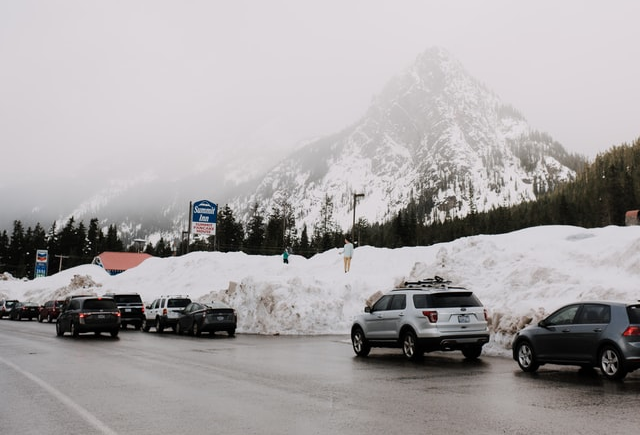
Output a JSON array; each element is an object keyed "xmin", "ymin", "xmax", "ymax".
[{"xmin": 56, "ymin": 296, "xmax": 120, "ymax": 337}]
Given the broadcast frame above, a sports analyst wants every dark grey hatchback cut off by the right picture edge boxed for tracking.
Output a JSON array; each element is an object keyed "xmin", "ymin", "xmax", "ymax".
[{"xmin": 512, "ymin": 301, "xmax": 640, "ymax": 379}]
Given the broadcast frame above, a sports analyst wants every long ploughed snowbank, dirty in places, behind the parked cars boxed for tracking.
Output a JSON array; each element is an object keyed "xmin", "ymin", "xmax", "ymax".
[{"xmin": 0, "ymin": 226, "xmax": 640, "ymax": 353}]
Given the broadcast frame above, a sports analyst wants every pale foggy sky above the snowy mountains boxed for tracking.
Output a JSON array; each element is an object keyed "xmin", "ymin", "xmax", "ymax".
[{"xmin": 0, "ymin": 0, "xmax": 640, "ymax": 186}]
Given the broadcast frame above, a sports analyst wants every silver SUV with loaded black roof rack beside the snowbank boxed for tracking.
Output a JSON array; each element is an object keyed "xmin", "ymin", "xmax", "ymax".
[{"xmin": 351, "ymin": 276, "xmax": 489, "ymax": 359}]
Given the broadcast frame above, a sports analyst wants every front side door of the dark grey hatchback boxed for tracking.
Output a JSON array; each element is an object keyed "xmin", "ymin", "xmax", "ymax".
[{"xmin": 533, "ymin": 304, "xmax": 580, "ymax": 361}]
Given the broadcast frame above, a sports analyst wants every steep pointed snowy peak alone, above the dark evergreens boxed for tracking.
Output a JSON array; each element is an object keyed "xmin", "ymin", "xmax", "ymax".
[{"xmin": 232, "ymin": 48, "xmax": 576, "ymax": 233}]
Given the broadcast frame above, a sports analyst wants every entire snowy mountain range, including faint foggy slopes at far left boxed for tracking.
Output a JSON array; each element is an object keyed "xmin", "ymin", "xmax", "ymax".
[{"xmin": 0, "ymin": 48, "xmax": 580, "ymax": 243}]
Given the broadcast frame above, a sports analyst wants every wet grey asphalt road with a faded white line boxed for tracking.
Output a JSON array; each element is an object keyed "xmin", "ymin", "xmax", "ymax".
[{"xmin": 0, "ymin": 319, "xmax": 640, "ymax": 435}]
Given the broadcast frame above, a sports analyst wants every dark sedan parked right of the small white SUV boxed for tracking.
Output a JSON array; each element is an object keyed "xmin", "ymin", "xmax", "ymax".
[{"xmin": 176, "ymin": 301, "xmax": 238, "ymax": 337}]
